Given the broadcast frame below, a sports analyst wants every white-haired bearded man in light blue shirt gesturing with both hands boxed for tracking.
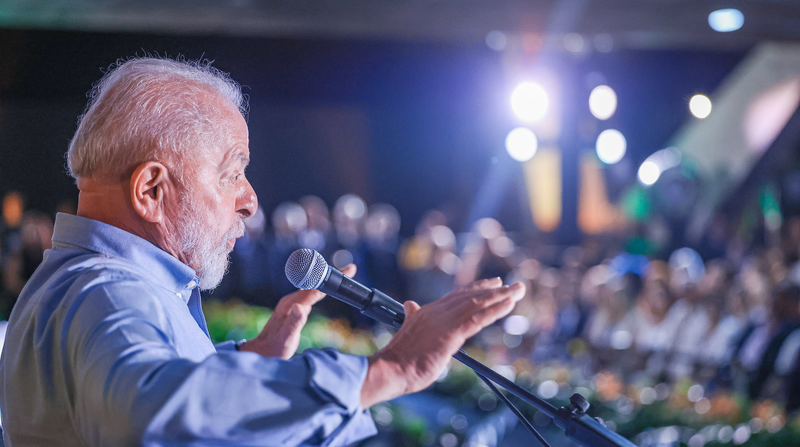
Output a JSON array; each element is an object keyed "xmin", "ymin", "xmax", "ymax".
[{"xmin": 0, "ymin": 58, "xmax": 524, "ymax": 447}]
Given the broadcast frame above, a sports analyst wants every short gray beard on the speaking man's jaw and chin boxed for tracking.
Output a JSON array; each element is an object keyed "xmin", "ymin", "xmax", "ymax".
[{"xmin": 175, "ymin": 200, "xmax": 244, "ymax": 290}]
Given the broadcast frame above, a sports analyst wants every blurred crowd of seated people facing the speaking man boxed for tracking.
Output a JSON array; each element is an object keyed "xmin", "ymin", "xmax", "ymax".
[{"xmin": 0, "ymin": 187, "xmax": 800, "ymax": 410}]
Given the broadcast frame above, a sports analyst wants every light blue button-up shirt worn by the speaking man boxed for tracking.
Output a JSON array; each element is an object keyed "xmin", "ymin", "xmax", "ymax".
[{"xmin": 0, "ymin": 214, "xmax": 376, "ymax": 447}]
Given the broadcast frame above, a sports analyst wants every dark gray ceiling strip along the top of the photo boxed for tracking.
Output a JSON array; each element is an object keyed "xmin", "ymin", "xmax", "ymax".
[{"xmin": 0, "ymin": 0, "xmax": 800, "ymax": 51}]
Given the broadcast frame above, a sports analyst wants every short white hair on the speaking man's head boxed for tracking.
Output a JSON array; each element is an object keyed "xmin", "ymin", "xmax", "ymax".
[{"xmin": 67, "ymin": 57, "xmax": 247, "ymax": 184}]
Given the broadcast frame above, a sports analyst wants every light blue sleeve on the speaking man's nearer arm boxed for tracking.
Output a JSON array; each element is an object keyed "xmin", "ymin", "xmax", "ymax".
[{"xmin": 65, "ymin": 282, "xmax": 376, "ymax": 446}]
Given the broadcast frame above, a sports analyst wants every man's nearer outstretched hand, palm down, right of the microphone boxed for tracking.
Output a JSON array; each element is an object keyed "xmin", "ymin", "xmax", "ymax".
[{"xmin": 361, "ymin": 278, "xmax": 525, "ymax": 408}]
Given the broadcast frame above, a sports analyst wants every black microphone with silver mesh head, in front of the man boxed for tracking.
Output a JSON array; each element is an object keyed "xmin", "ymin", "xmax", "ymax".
[{"xmin": 284, "ymin": 248, "xmax": 405, "ymax": 328}]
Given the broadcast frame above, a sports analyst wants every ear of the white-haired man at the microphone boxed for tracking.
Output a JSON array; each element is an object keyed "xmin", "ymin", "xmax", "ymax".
[{"xmin": 131, "ymin": 161, "xmax": 174, "ymax": 223}]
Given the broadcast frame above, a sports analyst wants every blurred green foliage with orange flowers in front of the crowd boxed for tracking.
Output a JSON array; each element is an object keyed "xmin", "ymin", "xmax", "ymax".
[{"xmin": 204, "ymin": 300, "xmax": 800, "ymax": 447}]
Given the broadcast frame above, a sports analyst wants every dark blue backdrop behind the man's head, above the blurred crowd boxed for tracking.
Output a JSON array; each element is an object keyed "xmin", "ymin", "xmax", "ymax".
[{"xmin": 0, "ymin": 29, "xmax": 745, "ymax": 235}]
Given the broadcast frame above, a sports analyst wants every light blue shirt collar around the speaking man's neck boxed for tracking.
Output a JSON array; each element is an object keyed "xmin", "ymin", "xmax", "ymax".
[{"xmin": 53, "ymin": 213, "xmax": 199, "ymax": 301}]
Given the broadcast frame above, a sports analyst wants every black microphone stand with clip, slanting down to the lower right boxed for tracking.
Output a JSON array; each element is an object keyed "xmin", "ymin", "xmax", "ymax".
[{"xmin": 368, "ymin": 289, "xmax": 636, "ymax": 447}]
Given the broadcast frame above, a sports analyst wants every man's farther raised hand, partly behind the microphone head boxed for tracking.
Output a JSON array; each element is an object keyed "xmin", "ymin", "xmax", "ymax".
[{"xmin": 239, "ymin": 264, "xmax": 356, "ymax": 359}]
